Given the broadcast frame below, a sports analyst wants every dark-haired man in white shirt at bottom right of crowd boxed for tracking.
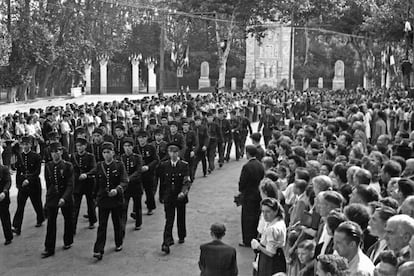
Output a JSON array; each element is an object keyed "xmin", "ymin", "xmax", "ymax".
[{"xmin": 334, "ymin": 221, "xmax": 375, "ymax": 276}]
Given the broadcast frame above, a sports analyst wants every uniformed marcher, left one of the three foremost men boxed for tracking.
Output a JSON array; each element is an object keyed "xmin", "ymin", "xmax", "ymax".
[{"xmin": 42, "ymin": 142, "xmax": 74, "ymax": 258}]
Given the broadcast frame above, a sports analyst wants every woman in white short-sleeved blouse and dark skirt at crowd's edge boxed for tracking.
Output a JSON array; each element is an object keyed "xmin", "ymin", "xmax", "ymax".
[{"xmin": 251, "ymin": 198, "xmax": 286, "ymax": 276}]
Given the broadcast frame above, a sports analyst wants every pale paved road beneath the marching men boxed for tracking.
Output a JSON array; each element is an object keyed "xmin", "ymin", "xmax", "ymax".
[{"xmin": 0, "ymin": 124, "xmax": 256, "ymax": 276}]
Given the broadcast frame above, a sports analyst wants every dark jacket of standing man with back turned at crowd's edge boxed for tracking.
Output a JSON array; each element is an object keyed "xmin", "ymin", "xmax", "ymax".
[{"xmin": 239, "ymin": 158, "xmax": 264, "ymax": 200}]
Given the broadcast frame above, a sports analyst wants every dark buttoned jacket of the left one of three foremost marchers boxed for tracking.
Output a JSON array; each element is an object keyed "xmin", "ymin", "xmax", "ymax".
[{"xmin": 45, "ymin": 160, "xmax": 74, "ymax": 207}]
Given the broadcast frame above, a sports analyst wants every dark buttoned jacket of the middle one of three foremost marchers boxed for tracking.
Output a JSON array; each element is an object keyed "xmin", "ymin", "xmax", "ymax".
[{"xmin": 93, "ymin": 160, "xmax": 128, "ymax": 208}]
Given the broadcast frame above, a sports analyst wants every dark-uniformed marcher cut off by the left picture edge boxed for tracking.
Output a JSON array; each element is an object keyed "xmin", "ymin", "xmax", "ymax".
[{"xmin": 0, "ymin": 164, "xmax": 13, "ymax": 245}]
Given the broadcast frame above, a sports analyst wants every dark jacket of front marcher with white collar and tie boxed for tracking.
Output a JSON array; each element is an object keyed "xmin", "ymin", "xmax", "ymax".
[{"xmin": 160, "ymin": 160, "xmax": 191, "ymax": 204}]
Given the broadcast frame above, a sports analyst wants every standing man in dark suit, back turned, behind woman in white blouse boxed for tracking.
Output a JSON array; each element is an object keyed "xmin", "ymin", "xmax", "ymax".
[{"xmin": 239, "ymin": 145, "xmax": 264, "ymax": 247}]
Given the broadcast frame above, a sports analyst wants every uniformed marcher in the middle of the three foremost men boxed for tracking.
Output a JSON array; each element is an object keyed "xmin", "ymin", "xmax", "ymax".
[{"xmin": 93, "ymin": 142, "xmax": 128, "ymax": 260}]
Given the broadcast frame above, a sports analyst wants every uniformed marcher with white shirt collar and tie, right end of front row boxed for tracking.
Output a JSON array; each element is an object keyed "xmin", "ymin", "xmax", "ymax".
[{"xmin": 160, "ymin": 143, "xmax": 191, "ymax": 254}]
